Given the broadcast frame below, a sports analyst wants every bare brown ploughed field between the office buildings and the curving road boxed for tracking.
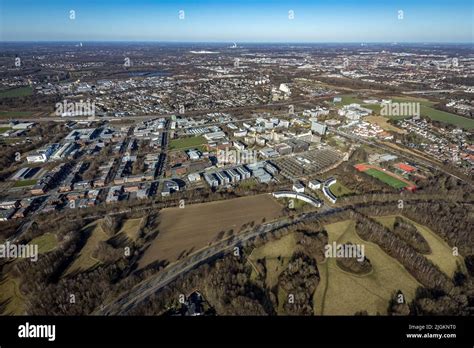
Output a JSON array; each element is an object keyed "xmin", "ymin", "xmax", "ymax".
[{"xmin": 139, "ymin": 194, "xmax": 282, "ymax": 268}]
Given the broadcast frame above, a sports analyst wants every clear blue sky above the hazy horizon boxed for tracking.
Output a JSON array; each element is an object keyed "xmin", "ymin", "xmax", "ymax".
[{"xmin": 0, "ymin": 0, "xmax": 474, "ymax": 42}]
